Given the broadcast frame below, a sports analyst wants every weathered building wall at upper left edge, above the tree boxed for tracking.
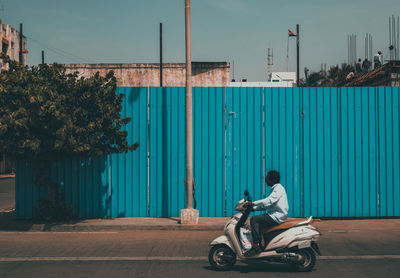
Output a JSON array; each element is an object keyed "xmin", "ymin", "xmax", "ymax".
[{"xmin": 0, "ymin": 20, "xmax": 27, "ymax": 68}]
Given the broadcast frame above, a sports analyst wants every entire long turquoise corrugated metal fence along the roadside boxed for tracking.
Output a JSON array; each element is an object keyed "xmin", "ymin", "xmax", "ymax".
[{"xmin": 16, "ymin": 87, "xmax": 400, "ymax": 218}]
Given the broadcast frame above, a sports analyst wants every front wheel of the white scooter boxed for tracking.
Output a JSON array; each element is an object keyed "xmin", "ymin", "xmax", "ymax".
[{"xmin": 208, "ymin": 244, "xmax": 236, "ymax": 271}]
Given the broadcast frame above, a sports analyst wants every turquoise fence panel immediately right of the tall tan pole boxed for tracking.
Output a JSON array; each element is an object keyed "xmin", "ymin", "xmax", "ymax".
[{"xmin": 195, "ymin": 88, "xmax": 226, "ymax": 216}]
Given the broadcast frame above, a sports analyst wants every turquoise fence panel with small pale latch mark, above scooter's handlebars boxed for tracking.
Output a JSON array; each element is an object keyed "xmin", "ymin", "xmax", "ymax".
[{"xmin": 225, "ymin": 87, "xmax": 265, "ymax": 215}]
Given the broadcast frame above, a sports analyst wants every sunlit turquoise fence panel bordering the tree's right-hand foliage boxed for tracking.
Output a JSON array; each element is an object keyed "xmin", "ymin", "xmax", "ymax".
[{"xmin": 106, "ymin": 87, "xmax": 148, "ymax": 217}]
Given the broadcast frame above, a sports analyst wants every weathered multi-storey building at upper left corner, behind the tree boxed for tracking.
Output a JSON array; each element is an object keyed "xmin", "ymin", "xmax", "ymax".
[{"xmin": 0, "ymin": 19, "xmax": 28, "ymax": 69}]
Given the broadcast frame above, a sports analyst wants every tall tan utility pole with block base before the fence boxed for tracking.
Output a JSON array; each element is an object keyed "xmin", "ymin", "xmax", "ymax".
[{"xmin": 181, "ymin": 0, "xmax": 199, "ymax": 224}]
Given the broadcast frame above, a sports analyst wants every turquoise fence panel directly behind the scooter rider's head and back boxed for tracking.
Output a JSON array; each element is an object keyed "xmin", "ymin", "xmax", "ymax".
[{"xmin": 264, "ymin": 88, "xmax": 304, "ymax": 216}]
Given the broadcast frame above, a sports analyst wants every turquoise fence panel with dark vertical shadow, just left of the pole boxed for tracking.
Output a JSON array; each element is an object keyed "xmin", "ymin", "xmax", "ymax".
[{"xmin": 148, "ymin": 87, "xmax": 186, "ymax": 217}]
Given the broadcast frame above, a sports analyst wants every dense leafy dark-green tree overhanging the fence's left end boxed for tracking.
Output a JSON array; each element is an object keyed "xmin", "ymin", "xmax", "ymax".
[{"xmin": 0, "ymin": 56, "xmax": 139, "ymax": 211}]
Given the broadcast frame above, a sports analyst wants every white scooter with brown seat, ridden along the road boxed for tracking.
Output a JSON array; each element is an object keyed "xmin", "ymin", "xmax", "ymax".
[{"xmin": 208, "ymin": 190, "xmax": 321, "ymax": 272}]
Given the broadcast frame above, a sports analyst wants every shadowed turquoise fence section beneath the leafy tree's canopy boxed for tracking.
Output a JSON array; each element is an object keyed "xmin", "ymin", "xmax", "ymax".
[{"xmin": 15, "ymin": 157, "xmax": 110, "ymax": 219}]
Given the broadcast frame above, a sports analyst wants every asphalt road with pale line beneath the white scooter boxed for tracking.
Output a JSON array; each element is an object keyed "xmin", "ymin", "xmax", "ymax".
[{"xmin": 0, "ymin": 227, "xmax": 400, "ymax": 278}]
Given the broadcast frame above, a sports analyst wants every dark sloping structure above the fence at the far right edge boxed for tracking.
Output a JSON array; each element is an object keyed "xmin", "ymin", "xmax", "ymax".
[{"xmin": 343, "ymin": 61, "xmax": 400, "ymax": 87}]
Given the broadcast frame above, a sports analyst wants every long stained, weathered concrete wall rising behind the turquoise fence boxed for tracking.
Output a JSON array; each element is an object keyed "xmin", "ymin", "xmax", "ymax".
[{"xmin": 65, "ymin": 62, "xmax": 230, "ymax": 87}]
